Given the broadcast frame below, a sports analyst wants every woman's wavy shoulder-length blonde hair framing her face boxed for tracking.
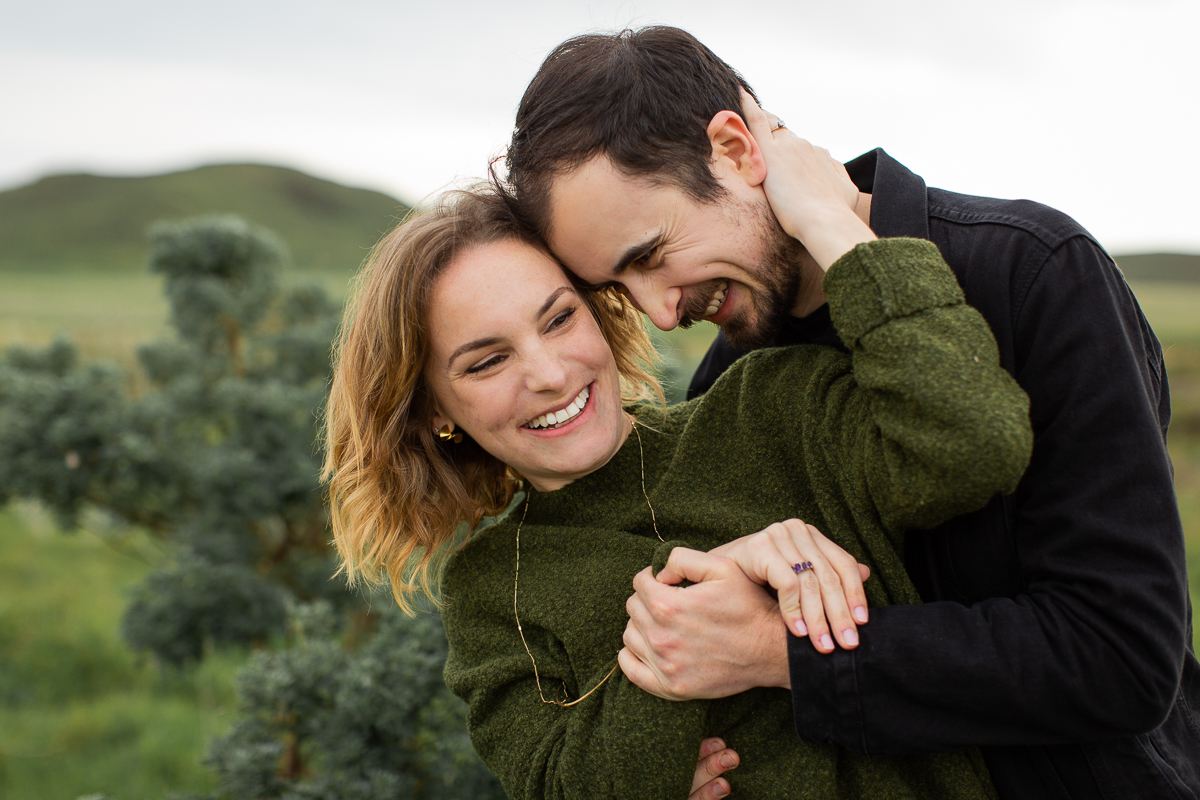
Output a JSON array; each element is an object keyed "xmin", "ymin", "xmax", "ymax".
[{"xmin": 323, "ymin": 187, "xmax": 662, "ymax": 613}]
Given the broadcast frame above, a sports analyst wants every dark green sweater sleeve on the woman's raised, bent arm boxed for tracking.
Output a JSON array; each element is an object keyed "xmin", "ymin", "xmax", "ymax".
[{"xmin": 714, "ymin": 239, "xmax": 1032, "ymax": 531}]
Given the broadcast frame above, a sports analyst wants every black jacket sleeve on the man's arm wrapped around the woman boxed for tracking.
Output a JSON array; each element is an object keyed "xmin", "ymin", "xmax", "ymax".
[{"xmin": 790, "ymin": 236, "xmax": 1190, "ymax": 753}]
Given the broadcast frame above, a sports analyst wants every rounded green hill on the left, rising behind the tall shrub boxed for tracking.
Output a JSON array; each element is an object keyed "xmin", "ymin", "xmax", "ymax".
[{"xmin": 0, "ymin": 164, "xmax": 408, "ymax": 275}]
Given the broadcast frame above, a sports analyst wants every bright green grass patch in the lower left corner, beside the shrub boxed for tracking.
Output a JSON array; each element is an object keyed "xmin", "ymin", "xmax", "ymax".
[{"xmin": 0, "ymin": 505, "xmax": 245, "ymax": 800}]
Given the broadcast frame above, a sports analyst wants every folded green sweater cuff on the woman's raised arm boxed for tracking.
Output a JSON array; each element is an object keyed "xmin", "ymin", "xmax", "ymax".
[{"xmin": 822, "ymin": 239, "xmax": 964, "ymax": 348}]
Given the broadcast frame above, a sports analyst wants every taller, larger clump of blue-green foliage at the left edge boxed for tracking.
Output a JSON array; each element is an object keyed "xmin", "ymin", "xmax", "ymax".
[{"xmin": 0, "ymin": 211, "xmax": 340, "ymax": 664}]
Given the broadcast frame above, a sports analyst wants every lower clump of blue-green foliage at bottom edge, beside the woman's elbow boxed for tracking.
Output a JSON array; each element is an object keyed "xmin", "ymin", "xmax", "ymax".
[{"xmin": 209, "ymin": 601, "xmax": 504, "ymax": 800}]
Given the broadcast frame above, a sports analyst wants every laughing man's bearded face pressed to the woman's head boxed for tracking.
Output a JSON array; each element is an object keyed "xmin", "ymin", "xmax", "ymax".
[{"xmin": 548, "ymin": 156, "xmax": 804, "ymax": 349}]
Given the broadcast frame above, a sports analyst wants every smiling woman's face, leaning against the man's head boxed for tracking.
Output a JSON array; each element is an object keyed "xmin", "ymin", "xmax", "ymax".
[{"xmin": 425, "ymin": 241, "xmax": 630, "ymax": 492}]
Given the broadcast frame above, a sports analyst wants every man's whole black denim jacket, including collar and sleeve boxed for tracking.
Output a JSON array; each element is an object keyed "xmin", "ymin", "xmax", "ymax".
[{"xmin": 689, "ymin": 150, "xmax": 1200, "ymax": 800}]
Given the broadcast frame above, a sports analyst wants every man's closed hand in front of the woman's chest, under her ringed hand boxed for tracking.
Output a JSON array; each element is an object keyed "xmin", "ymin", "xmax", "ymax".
[{"xmin": 618, "ymin": 547, "xmax": 791, "ymax": 700}]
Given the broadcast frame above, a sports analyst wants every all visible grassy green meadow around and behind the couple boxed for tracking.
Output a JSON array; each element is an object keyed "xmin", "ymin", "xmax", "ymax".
[{"xmin": 0, "ymin": 271, "xmax": 1200, "ymax": 800}]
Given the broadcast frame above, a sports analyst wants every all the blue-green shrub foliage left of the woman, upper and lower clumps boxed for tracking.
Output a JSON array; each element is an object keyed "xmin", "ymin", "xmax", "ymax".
[{"xmin": 0, "ymin": 217, "xmax": 503, "ymax": 800}]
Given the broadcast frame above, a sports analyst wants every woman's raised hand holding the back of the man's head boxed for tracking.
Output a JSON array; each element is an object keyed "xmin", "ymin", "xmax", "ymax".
[{"xmin": 742, "ymin": 90, "xmax": 876, "ymax": 270}]
